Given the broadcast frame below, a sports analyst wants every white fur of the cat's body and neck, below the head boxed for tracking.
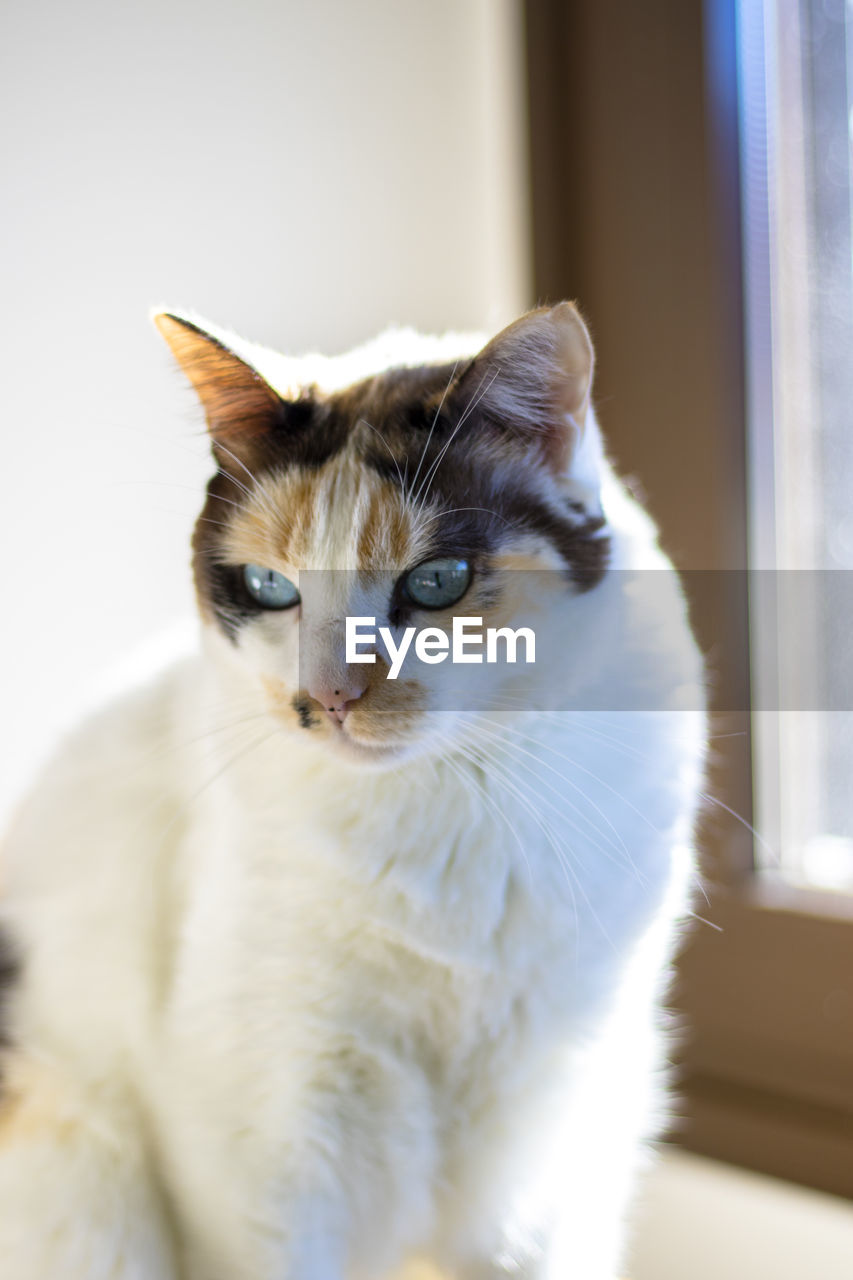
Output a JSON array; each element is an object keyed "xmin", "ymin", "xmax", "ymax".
[{"xmin": 0, "ymin": 389, "xmax": 704, "ymax": 1280}]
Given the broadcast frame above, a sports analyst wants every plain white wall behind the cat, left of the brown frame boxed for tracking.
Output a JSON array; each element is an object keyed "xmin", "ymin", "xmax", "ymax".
[{"xmin": 0, "ymin": 0, "xmax": 530, "ymax": 804}]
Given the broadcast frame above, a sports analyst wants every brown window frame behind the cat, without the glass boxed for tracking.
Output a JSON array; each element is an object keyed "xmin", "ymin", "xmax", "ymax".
[{"xmin": 525, "ymin": 0, "xmax": 853, "ymax": 1197}]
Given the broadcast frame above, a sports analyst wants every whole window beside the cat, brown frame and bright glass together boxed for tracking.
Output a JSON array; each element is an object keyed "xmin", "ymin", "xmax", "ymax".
[{"xmin": 526, "ymin": 0, "xmax": 853, "ymax": 1196}]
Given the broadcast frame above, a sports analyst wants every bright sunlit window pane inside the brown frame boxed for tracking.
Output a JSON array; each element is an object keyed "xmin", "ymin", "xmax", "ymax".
[{"xmin": 739, "ymin": 0, "xmax": 853, "ymax": 892}]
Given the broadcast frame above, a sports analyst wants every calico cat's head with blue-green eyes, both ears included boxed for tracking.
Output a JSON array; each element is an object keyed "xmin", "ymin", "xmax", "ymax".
[{"xmin": 155, "ymin": 302, "xmax": 608, "ymax": 763}]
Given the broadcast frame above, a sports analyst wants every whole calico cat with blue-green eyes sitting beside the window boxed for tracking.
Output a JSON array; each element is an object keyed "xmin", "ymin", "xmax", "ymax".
[{"xmin": 0, "ymin": 303, "xmax": 704, "ymax": 1280}]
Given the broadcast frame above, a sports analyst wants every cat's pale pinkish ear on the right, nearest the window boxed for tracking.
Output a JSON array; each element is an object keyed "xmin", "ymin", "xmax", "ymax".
[{"xmin": 465, "ymin": 302, "xmax": 594, "ymax": 475}]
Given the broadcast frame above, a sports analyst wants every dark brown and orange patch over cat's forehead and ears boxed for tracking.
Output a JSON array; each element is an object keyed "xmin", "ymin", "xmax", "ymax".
[{"xmin": 167, "ymin": 296, "xmax": 608, "ymax": 637}]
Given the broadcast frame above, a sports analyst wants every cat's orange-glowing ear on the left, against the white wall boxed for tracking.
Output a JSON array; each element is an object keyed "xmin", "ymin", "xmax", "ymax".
[{"xmin": 151, "ymin": 311, "xmax": 283, "ymax": 453}]
